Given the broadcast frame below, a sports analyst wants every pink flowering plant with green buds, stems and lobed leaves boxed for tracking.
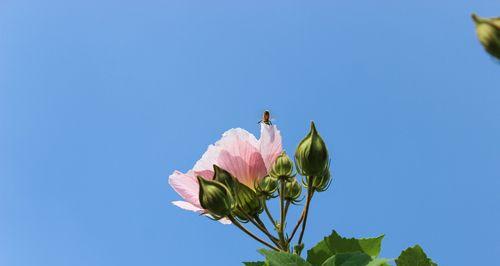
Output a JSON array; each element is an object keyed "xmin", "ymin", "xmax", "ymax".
[{"xmin": 169, "ymin": 115, "xmax": 437, "ymax": 266}]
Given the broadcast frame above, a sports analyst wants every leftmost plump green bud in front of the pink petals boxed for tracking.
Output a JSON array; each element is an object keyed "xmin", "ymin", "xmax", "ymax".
[{"xmin": 197, "ymin": 176, "xmax": 234, "ymax": 220}]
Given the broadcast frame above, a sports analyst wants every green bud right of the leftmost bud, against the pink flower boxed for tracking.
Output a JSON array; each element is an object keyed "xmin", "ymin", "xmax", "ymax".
[{"xmin": 233, "ymin": 182, "xmax": 263, "ymax": 222}]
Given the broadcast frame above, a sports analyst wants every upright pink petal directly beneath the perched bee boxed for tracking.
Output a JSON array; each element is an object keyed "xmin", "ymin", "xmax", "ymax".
[{"xmin": 259, "ymin": 123, "xmax": 283, "ymax": 171}]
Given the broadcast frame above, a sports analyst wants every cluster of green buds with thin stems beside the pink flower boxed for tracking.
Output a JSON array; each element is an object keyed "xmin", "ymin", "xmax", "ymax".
[{"xmin": 198, "ymin": 118, "xmax": 331, "ymax": 253}]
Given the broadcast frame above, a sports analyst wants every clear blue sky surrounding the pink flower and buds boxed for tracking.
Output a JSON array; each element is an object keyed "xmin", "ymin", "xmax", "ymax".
[{"xmin": 0, "ymin": 0, "xmax": 500, "ymax": 266}]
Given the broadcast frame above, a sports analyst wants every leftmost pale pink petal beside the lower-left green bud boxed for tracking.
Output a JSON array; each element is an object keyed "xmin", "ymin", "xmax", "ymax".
[{"xmin": 168, "ymin": 171, "xmax": 201, "ymax": 208}]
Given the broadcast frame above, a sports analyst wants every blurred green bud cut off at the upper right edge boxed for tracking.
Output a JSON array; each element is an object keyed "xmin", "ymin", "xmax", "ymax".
[{"xmin": 472, "ymin": 14, "xmax": 500, "ymax": 59}]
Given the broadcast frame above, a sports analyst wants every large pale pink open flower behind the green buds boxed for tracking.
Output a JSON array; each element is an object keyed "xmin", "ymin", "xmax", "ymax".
[{"xmin": 168, "ymin": 123, "xmax": 282, "ymax": 223}]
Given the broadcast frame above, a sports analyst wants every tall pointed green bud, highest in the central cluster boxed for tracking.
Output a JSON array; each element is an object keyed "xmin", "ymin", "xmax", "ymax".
[{"xmin": 295, "ymin": 122, "xmax": 329, "ymax": 176}]
